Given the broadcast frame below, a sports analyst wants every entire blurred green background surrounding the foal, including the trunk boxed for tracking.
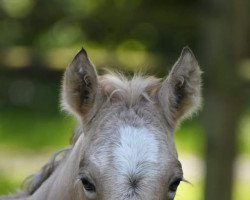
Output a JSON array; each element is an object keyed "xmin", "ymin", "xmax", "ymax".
[{"xmin": 0, "ymin": 0, "xmax": 250, "ymax": 200}]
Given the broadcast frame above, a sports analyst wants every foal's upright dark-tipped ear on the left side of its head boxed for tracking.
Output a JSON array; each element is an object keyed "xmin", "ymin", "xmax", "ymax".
[{"xmin": 62, "ymin": 48, "xmax": 98, "ymax": 117}]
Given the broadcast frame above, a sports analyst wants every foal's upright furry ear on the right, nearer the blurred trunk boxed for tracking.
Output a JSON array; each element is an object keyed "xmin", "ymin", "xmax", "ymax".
[{"xmin": 158, "ymin": 47, "xmax": 201, "ymax": 127}]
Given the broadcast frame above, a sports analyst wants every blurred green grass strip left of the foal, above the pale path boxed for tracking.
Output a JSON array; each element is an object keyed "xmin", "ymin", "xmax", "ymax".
[{"xmin": 0, "ymin": 110, "xmax": 75, "ymax": 150}]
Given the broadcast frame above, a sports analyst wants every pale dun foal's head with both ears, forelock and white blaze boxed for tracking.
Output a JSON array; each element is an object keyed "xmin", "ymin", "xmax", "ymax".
[{"xmin": 62, "ymin": 47, "xmax": 201, "ymax": 200}]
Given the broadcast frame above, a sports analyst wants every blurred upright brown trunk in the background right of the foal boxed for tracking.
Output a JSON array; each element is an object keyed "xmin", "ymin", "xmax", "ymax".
[{"xmin": 201, "ymin": 0, "xmax": 250, "ymax": 200}]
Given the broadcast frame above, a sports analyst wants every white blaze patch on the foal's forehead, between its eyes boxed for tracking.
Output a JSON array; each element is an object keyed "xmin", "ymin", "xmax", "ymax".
[{"xmin": 114, "ymin": 126, "xmax": 159, "ymax": 182}]
